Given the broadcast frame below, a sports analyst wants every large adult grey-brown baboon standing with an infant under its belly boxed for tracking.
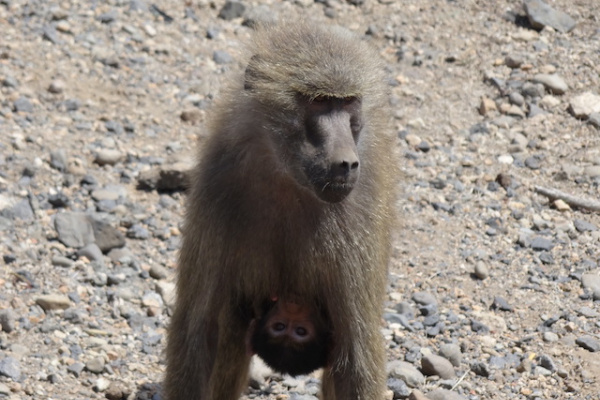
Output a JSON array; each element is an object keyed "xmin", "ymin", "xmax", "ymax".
[{"xmin": 164, "ymin": 21, "xmax": 397, "ymax": 400}]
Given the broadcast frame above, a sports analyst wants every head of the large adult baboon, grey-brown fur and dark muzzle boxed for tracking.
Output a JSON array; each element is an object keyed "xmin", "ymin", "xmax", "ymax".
[{"xmin": 244, "ymin": 23, "xmax": 380, "ymax": 203}]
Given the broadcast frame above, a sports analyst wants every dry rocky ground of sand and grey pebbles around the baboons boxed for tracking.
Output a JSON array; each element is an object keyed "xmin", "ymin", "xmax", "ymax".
[{"xmin": 0, "ymin": 0, "xmax": 600, "ymax": 400}]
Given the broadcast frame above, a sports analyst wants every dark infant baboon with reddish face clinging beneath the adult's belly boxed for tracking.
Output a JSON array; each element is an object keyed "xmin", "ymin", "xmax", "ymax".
[{"xmin": 248, "ymin": 299, "xmax": 331, "ymax": 375}]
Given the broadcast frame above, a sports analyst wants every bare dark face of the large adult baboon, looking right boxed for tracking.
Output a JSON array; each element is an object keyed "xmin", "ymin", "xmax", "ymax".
[{"xmin": 280, "ymin": 95, "xmax": 362, "ymax": 203}]
